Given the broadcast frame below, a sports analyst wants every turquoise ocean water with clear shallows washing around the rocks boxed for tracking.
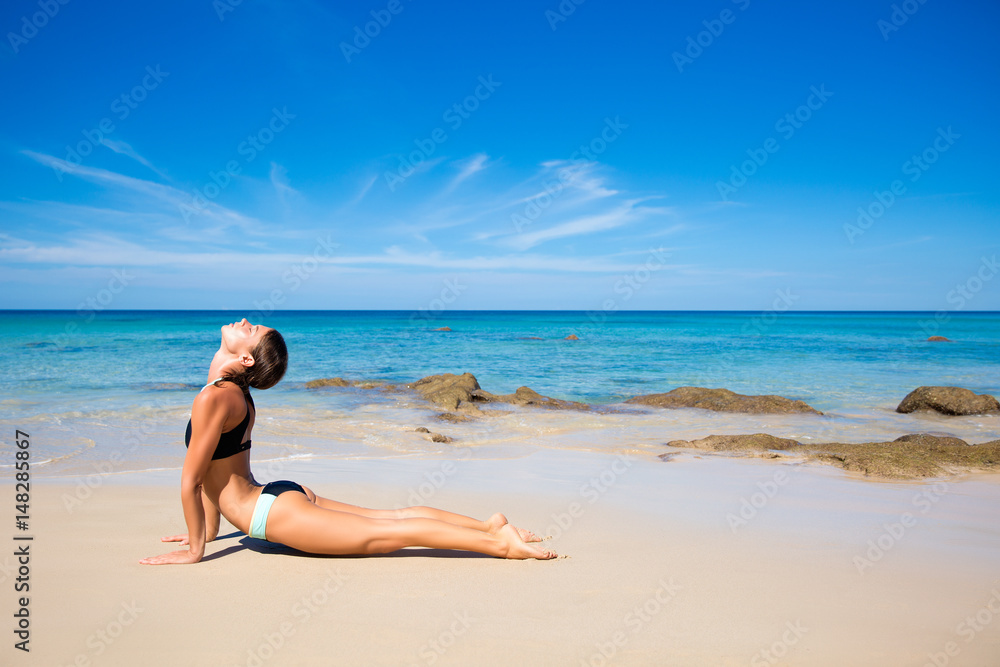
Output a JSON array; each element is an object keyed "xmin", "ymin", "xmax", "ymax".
[{"xmin": 0, "ymin": 311, "xmax": 1000, "ymax": 476}]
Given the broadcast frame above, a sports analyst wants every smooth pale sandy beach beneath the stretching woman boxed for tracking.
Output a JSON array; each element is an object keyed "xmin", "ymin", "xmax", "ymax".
[{"xmin": 15, "ymin": 451, "xmax": 1000, "ymax": 666}]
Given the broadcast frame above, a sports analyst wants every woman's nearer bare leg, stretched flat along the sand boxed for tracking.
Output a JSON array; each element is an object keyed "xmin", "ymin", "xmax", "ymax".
[{"xmin": 266, "ymin": 492, "xmax": 556, "ymax": 559}]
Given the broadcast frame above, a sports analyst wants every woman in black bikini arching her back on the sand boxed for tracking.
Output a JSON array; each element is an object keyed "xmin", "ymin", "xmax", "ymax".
[{"xmin": 139, "ymin": 318, "xmax": 556, "ymax": 565}]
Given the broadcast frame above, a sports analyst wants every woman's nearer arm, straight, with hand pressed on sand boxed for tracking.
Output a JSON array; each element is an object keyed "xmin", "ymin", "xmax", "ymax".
[{"xmin": 139, "ymin": 391, "xmax": 226, "ymax": 565}]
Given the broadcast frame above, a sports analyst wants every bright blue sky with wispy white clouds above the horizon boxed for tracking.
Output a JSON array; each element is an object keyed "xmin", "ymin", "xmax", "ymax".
[{"xmin": 0, "ymin": 0, "xmax": 1000, "ymax": 311}]
